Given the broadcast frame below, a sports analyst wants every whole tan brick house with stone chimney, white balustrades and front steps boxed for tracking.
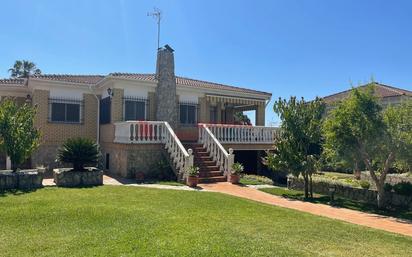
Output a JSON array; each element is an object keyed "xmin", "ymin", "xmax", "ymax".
[{"xmin": 0, "ymin": 46, "xmax": 275, "ymax": 181}]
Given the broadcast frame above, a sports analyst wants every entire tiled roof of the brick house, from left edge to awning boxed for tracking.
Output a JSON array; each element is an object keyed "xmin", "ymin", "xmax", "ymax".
[{"xmin": 0, "ymin": 73, "xmax": 272, "ymax": 96}]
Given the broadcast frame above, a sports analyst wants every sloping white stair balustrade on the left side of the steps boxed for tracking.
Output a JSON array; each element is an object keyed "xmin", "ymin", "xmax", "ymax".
[{"xmin": 162, "ymin": 121, "xmax": 193, "ymax": 179}]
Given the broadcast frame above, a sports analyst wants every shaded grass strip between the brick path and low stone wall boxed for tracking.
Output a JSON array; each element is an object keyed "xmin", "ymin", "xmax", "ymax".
[{"xmin": 260, "ymin": 188, "xmax": 412, "ymax": 220}]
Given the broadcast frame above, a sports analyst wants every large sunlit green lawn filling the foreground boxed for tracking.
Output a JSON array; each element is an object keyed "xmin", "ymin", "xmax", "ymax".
[{"xmin": 0, "ymin": 186, "xmax": 412, "ymax": 257}]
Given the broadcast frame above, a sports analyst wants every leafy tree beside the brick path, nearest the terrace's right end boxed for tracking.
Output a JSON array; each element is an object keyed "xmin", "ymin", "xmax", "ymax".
[{"xmin": 266, "ymin": 97, "xmax": 324, "ymax": 198}]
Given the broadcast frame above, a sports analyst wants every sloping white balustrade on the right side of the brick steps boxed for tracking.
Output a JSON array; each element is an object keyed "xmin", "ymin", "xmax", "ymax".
[{"xmin": 199, "ymin": 124, "xmax": 235, "ymax": 175}]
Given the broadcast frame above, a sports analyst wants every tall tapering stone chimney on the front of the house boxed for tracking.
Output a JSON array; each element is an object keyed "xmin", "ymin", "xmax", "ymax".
[{"xmin": 156, "ymin": 45, "xmax": 178, "ymax": 129}]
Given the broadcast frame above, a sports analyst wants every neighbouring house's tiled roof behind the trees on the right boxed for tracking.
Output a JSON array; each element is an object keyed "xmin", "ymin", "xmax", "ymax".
[{"xmin": 323, "ymin": 82, "xmax": 412, "ymax": 103}]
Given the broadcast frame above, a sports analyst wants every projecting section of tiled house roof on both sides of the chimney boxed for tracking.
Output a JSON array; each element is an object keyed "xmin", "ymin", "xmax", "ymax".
[{"xmin": 109, "ymin": 73, "xmax": 272, "ymax": 95}]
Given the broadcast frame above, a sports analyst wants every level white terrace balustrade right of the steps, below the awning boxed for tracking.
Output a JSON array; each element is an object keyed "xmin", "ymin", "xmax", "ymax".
[{"xmin": 199, "ymin": 124, "xmax": 278, "ymax": 144}]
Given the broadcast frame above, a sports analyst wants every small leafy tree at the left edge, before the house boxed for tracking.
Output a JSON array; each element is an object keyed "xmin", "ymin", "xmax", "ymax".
[{"xmin": 0, "ymin": 99, "xmax": 40, "ymax": 171}]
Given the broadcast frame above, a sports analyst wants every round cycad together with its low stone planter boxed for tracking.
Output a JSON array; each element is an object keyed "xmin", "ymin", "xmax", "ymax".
[{"xmin": 53, "ymin": 137, "xmax": 103, "ymax": 187}]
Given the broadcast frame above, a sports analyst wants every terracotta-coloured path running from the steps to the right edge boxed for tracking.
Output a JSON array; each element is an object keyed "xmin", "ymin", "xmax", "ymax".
[{"xmin": 198, "ymin": 182, "xmax": 412, "ymax": 236}]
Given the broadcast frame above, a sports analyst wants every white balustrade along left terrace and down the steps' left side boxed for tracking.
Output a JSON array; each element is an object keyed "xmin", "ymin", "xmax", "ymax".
[{"xmin": 114, "ymin": 121, "xmax": 193, "ymax": 176}]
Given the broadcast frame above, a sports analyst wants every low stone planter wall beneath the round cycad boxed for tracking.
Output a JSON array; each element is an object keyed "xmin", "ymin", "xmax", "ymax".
[{"xmin": 53, "ymin": 168, "xmax": 103, "ymax": 187}]
